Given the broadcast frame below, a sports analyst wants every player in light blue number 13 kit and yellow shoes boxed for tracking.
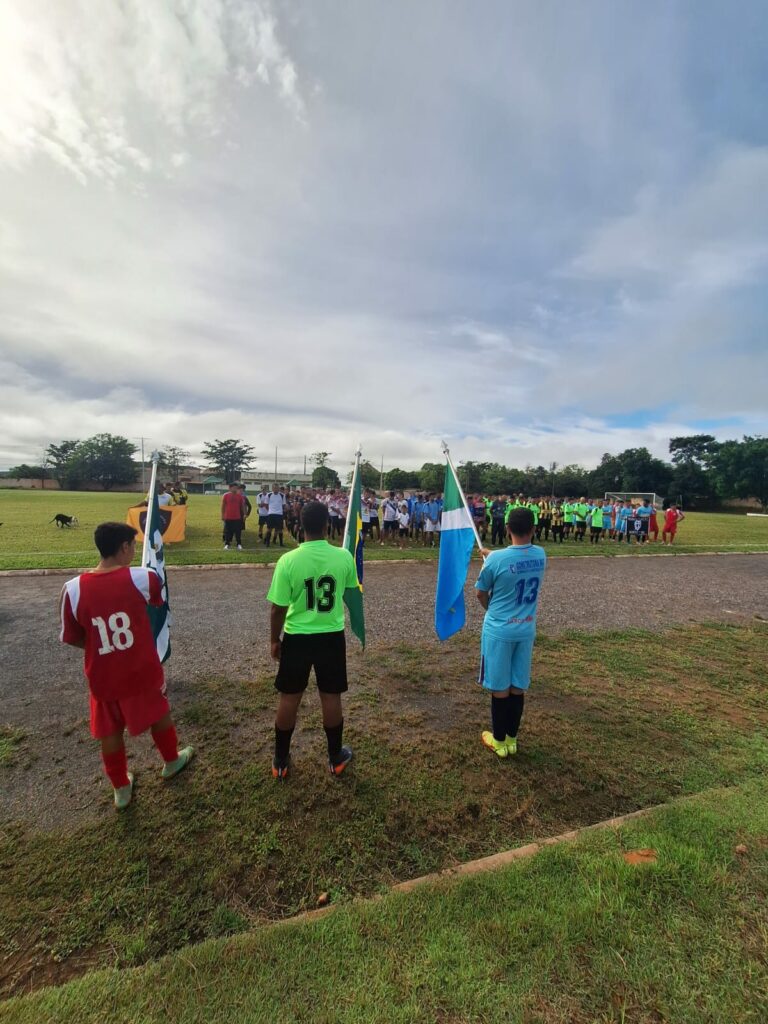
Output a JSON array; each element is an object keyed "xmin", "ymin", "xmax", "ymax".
[{"xmin": 475, "ymin": 508, "xmax": 547, "ymax": 758}]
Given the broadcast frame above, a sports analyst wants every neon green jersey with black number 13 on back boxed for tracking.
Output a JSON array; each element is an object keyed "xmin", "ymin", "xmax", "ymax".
[{"xmin": 266, "ymin": 541, "xmax": 357, "ymax": 633}]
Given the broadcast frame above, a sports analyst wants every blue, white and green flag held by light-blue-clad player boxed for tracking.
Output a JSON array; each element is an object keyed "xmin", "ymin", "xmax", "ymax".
[{"xmin": 434, "ymin": 449, "xmax": 480, "ymax": 640}]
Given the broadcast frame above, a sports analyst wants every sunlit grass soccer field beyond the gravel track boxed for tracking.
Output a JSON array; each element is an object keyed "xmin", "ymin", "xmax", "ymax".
[{"xmin": 0, "ymin": 489, "xmax": 768, "ymax": 569}]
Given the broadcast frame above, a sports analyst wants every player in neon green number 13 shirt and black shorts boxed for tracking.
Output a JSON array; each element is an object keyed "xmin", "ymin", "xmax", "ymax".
[{"xmin": 266, "ymin": 501, "xmax": 357, "ymax": 779}]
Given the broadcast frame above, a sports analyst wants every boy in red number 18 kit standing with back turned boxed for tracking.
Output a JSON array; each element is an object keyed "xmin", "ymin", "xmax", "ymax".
[{"xmin": 59, "ymin": 522, "xmax": 195, "ymax": 810}]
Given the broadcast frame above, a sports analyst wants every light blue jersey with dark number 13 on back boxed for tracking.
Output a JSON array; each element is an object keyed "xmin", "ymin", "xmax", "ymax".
[{"xmin": 475, "ymin": 544, "xmax": 547, "ymax": 640}]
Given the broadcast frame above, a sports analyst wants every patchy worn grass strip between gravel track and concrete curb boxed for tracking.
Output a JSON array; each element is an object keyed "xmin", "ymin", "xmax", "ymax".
[{"xmin": 0, "ymin": 626, "xmax": 768, "ymax": 999}]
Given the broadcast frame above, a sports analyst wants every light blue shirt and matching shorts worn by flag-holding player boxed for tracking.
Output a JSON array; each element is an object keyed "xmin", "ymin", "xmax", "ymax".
[{"xmin": 475, "ymin": 544, "xmax": 547, "ymax": 691}]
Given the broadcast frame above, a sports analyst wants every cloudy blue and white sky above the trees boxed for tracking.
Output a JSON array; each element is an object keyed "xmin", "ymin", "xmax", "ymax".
[{"xmin": 0, "ymin": 0, "xmax": 768, "ymax": 468}]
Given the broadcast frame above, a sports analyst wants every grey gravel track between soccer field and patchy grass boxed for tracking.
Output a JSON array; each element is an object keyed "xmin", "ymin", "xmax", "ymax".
[{"xmin": 0, "ymin": 555, "xmax": 768, "ymax": 827}]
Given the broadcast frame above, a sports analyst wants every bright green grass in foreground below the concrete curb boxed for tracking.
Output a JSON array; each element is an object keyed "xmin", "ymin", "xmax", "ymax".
[{"xmin": 0, "ymin": 779, "xmax": 768, "ymax": 1024}]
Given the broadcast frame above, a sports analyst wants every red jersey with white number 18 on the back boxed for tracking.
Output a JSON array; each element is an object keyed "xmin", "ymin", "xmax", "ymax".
[{"xmin": 59, "ymin": 566, "xmax": 164, "ymax": 700}]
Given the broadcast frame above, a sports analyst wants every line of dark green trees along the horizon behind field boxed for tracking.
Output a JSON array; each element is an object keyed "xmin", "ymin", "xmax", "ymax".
[{"xmin": 7, "ymin": 434, "xmax": 768, "ymax": 508}]
